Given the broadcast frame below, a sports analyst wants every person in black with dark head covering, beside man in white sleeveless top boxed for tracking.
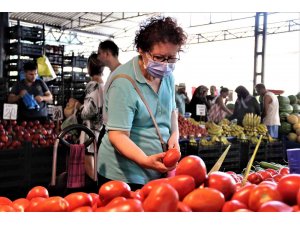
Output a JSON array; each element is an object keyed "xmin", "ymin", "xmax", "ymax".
[{"xmin": 229, "ymin": 86, "xmax": 260, "ymax": 126}]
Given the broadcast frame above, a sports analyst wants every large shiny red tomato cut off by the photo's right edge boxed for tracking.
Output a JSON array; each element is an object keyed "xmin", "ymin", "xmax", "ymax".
[{"xmin": 277, "ymin": 174, "xmax": 300, "ymax": 205}]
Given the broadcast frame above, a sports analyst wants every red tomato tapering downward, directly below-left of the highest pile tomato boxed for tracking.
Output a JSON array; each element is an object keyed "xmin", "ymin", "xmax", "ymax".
[{"xmin": 167, "ymin": 175, "xmax": 196, "ymax": 200}]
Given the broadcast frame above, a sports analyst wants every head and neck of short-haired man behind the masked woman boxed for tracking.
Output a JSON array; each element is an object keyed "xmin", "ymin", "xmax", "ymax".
[{"xmin": 98, "ymin": 40, "xmax": 121, "ymax": 72}]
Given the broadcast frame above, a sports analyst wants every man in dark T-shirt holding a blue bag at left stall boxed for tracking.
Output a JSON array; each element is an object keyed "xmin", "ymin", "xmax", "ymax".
[{"xmin": 8, "ymin": 61, "xmax": 52, "ymax": 122}]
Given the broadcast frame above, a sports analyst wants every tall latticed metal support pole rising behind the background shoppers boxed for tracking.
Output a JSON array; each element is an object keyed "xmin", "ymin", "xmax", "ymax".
[{"xmin": 253, "ymin": 12, "xmax": 267, "ymax": 94}]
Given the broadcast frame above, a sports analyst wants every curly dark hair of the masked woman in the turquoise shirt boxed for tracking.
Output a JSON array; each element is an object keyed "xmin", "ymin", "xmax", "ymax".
[{"xmin": 134, "ymin": 17, "xmax": 187, "ymax": 52}]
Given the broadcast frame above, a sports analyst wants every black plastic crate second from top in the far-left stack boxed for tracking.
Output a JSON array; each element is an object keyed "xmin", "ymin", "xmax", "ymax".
[{"xmin": 7, "ymin": 42, "xmax": 43, "ymax": 57}]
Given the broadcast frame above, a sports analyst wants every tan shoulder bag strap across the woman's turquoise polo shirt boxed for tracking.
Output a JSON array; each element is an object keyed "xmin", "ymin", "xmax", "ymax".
[{"xmin": 107, "ymin": 74, "xmax": 167, "ymax": 151}]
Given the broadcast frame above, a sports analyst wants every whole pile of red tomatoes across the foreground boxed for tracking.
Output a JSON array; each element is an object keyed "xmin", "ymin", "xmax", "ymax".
[{"xmin": 0, "ymin": 156, "xmax": 300, "ymax": 212}]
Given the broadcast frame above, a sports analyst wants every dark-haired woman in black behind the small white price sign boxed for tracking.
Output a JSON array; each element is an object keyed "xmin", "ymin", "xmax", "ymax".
[{"xmin": 188, "ymin": 85, "xmax": 210, "ymax": 121}]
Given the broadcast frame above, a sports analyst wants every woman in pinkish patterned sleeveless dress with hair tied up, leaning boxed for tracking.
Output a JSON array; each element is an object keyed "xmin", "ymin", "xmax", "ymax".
[{"xmin": 208, "ymin": 87, "xmax": 232, "ymax": 123}]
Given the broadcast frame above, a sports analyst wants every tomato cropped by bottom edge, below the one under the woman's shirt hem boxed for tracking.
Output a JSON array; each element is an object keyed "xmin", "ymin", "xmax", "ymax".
[{"xmin": 102, "ymin": 199, "xmax": 144, "ymax": 212}]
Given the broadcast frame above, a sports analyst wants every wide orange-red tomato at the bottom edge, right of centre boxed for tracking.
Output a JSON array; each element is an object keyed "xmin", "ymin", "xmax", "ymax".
[{"xmin": 183, "ymin": 188, "xmax": 225, "ymax": 212}]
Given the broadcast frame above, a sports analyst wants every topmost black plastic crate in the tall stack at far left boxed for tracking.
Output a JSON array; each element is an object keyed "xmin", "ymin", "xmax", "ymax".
[{"xmin": 7, "ymin": 25, "xmax": 45, "ymax": 42}]
